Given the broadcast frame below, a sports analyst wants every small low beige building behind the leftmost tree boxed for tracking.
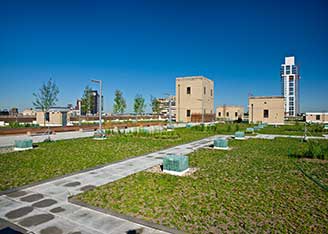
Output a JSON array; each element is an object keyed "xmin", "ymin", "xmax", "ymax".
[{"xmin": 36, "ymin": 107, "xmax": 70, "ymax": 126}]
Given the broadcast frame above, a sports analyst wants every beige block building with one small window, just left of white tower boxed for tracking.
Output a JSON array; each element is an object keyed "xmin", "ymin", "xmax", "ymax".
[{"xmin": 248, "ymin": 96, "xmax": 285, "ymax": 124}]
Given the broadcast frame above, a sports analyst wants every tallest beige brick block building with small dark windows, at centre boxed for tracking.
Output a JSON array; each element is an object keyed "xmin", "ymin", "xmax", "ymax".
[{"xmin": 176, "ymin": 76, "xmax": 215, "ymax": 122}]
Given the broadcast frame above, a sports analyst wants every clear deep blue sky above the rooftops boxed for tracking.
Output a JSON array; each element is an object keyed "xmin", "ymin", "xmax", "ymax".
[{"xmin": 0, "ymin": 0, "xmax": 328, "ymax": 111}]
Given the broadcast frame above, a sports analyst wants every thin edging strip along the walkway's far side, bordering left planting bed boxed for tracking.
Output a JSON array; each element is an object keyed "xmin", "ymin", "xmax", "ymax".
[{"xmin": 0, "ymin": 136, "xmax": 214, "ymax": 196}]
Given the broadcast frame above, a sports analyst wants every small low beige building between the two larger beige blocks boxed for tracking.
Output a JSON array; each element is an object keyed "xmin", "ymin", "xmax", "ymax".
[{"xmin": 216, "ymin": 105, "xmax": 244, "ymax": 121}]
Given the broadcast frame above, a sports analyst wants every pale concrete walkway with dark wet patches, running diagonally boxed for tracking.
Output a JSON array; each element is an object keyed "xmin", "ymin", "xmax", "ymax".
[{"xmin": 0, "ymin": 137, "xmax": 220, "ymax": 234}]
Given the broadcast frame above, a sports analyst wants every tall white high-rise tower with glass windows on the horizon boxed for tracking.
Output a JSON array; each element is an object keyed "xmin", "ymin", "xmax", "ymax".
[{"xmin": 280, "ymin": 56, "xmax": 300, "ymax": 116}]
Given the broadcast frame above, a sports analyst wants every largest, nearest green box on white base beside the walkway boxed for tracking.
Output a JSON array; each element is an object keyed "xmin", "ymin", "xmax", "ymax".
[{"xmin": 163, "ymin": 155, "xmax": 189, "ymax": 172}]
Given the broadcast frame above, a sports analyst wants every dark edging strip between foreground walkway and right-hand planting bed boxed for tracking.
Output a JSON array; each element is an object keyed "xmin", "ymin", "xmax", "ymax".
[{"xmin": 68, "ymin": 197, "xmax": 184, "ymax": 234}]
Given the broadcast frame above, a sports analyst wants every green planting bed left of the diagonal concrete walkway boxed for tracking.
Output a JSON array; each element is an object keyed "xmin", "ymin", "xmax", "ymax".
[{"xmin": 0, "ymin": 129, "xmax": 211, "ymax": 191}]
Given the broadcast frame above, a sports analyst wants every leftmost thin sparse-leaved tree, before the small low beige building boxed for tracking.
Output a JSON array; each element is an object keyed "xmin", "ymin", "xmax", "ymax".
[{"xmin": 33, "ymin": 78, "xmax": 59, "ymax": 137}]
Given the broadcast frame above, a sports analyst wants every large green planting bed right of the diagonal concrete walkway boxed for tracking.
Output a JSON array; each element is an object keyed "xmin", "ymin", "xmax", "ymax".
[{"xmin": 78, "ymin": 138, "xmax": 328, "ymax": 233}]
